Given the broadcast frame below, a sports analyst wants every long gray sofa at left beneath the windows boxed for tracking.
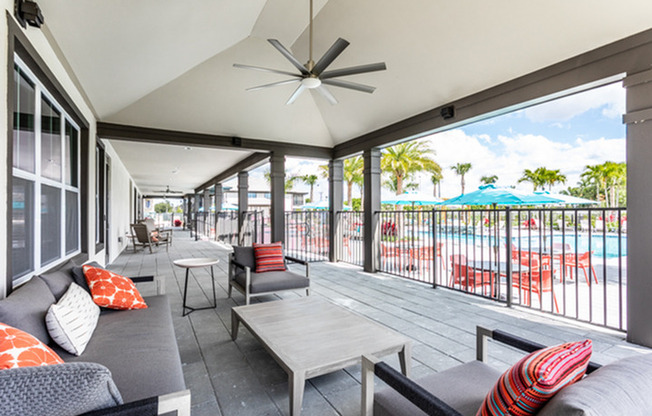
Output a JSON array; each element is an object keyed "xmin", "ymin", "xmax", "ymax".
[{"xmin": 0, "ymin": 262, "xmax": 190, "ymax": 416}]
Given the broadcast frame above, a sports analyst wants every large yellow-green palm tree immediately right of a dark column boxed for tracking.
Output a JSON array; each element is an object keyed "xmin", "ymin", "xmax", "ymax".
[{"xmin": 380, "ymin": 141, "xmax": 441, "ymax": 195}]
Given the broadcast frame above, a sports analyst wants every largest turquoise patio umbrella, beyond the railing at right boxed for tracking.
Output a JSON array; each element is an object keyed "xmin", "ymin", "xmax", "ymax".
[{"xmin": 441, "ymin": 184, "xmax": 562, "ymax": 205}]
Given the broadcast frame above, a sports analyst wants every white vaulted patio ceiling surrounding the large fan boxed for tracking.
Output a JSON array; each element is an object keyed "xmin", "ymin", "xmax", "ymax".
[{"xmin": 39, "ymin": 0, "xmax": 652, "ymax": 192}]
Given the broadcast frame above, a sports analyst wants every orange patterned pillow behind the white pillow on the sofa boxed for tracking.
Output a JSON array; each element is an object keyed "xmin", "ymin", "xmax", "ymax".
[{"xmin": 84, "ymin": 266, "xmax": 147, "ymax": 310}]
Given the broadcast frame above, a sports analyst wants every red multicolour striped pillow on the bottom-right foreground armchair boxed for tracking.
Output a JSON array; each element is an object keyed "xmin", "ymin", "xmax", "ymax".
[{"xmin": 477, "ymin": 339, "xmax": 591, "ymax": 416}]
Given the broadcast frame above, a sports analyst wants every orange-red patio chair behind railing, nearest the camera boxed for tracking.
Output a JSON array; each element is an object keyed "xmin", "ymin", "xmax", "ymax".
[{"xmin": 512, "ymin": 254, "xmax": 559, "ymax": 313}]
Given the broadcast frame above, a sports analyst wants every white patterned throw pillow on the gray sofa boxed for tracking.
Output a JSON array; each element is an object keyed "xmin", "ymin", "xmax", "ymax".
[{"xmin": 45, "ymin": 283, "xmax": 100, "ymax": 355}]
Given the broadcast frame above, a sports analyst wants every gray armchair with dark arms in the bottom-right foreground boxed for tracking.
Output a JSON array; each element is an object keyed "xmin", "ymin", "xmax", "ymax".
[{"xmin": 362, "ymin": 327, "xmax": 652, "ymax": 416}]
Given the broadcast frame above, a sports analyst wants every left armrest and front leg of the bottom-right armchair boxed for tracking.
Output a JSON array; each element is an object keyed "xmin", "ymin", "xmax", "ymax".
[{"xmin": 362, "ymin": 356, "xmax": 462, "ymax": 416}]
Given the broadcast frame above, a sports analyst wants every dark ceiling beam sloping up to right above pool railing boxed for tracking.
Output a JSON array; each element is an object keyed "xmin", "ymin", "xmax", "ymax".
[{"xmin": 333, "ymin": 26, "xmax": 652, "ymax": 159}]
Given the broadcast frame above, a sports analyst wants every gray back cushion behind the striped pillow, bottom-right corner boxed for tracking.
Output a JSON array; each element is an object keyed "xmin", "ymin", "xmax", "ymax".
[{"xmin": 538, "ymin": 354, "xmax": 652, "ymax": 416}]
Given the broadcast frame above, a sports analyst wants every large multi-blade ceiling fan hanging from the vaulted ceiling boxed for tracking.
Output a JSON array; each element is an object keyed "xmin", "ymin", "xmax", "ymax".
[{"xmin": 233, "ymin": 0, "xmax": 387, "ymax": 104}]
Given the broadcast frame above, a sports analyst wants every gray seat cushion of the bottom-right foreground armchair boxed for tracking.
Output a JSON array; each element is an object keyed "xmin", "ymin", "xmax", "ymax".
[{"xmin": 374, "ymin": 361, "xmax": 500, "ymax": 416}]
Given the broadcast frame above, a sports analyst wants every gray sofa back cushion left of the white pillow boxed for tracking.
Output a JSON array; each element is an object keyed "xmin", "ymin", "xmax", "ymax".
[{"xmin": 0, "ymin": 277, "xmax": 56, "ymax": 344}]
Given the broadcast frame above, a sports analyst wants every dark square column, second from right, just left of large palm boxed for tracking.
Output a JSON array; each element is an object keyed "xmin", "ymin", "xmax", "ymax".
[{"xmin": 362, "ymin": 148, "xmax": 381, "ymax": 273}]
